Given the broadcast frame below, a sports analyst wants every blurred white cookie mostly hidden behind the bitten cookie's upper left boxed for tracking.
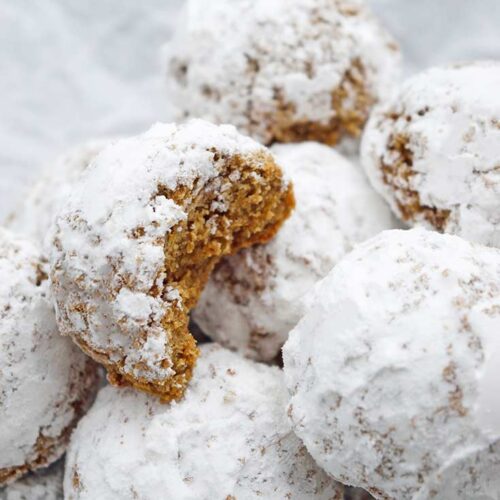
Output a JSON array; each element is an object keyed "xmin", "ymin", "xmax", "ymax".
[{"xmin": 6, "ymin": 141, "xmax": 108, "ymax": 246}]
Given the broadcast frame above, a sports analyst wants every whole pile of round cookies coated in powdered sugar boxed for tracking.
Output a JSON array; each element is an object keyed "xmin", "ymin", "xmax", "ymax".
[{"xmin": 0, "ymin": 0, "xmax": 500, "ymax": 500}]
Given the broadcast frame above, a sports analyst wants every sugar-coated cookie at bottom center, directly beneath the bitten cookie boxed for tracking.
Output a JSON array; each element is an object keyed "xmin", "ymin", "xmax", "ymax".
[{"xmin": 64, "ymin": 344, "xmax": 343, "ymax": 500}]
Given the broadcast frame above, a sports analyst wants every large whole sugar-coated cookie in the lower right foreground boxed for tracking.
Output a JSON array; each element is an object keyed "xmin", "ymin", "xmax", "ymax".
[{"xmin": 283, "ymin": 229, "xmax": 500, "ymax": 500}]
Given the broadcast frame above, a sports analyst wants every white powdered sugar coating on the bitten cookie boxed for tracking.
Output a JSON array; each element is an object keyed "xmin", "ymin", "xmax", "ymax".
[{"xmin": 51, "ymin": 120, "xmax": 269, "ymax": 383}]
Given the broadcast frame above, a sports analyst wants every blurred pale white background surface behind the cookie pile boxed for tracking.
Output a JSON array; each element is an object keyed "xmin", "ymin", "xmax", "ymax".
[{"xmin": 0, "ymin": 0, "xmax": 500, "ymax": 220}]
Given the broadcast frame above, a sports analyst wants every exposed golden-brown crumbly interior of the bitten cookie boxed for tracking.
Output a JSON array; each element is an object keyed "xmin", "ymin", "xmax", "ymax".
[{"xmin": 110, "ymin": 150, "xmax": 294, "ymax": 401}]
